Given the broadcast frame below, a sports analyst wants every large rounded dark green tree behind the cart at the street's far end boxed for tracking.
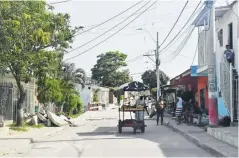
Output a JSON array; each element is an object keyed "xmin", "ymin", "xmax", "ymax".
[{"xmin": 91, "ymin": 51, "xmax": 131, "ymax": 87}]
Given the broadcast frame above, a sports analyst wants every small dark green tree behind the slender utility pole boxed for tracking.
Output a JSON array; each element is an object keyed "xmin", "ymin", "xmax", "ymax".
[{"xmin": 141, "ymin": 70, "xmax": 169, "ymax": 89}]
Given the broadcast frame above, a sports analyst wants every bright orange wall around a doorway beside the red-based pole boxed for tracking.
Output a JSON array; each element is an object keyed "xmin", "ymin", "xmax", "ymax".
[{"xmin": 197, "ymin": 76, "xmax": 208, "ymax": 109}]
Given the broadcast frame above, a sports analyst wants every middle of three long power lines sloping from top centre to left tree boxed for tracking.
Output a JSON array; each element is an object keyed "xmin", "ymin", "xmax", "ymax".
[{"xmin": 68, "ymin": 1, "xmax": 150, "ymax": 53}]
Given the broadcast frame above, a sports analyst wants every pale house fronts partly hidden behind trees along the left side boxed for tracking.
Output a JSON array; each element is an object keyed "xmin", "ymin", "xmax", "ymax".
[{"xmin": 0, "ymin": 74, "xmax": 116, "ymax": 120}]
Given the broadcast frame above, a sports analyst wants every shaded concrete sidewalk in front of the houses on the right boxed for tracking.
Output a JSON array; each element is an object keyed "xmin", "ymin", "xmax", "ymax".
[{"xmin": 164, "ymin": 117, "xmax": 238, "ymax": 157}]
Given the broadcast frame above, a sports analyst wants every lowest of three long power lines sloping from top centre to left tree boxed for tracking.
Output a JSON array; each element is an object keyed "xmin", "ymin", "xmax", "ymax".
[{"xmin": 65, "ymin": 1, "xmax": 156, "ymax": 61}]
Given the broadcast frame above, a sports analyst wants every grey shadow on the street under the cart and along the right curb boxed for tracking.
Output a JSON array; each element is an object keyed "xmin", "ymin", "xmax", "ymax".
[{"xmin": 74, "ymin": 120, "xmax": 210, "ymax": 157}]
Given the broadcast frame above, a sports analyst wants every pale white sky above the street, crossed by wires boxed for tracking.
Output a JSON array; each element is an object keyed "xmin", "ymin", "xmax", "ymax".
[{"xmin": 47, "ymin": 0, "xmax": 233, "ymax": 81}]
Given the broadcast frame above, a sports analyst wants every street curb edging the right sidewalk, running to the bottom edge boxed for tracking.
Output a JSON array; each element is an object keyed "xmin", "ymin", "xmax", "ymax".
[{"xmin": 164, "ymin": 122, "xmax": 225, "ymax": 157}]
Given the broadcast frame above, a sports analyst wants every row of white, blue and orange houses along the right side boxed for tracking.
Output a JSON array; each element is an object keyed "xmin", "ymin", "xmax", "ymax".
[{"xmin": 170, "ymin": 1, "xmax": 239, "ymax": 122}]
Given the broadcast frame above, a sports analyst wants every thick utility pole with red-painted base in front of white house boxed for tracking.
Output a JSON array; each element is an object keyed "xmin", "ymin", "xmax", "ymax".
[{"xmin": 205, "ymin": 0, "xmax": 219, "ymax": 126}]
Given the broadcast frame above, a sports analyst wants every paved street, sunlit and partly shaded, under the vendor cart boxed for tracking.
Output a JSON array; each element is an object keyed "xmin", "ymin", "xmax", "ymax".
[{"xmin": 21, "ymin": 111, "xmax": 211, "ymax": 157}]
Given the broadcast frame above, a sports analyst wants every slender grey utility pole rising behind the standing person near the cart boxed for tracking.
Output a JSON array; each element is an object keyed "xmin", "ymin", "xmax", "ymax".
[{"xmin": 155, "ymin": 32, "xmax": 161, "ymax": 101}]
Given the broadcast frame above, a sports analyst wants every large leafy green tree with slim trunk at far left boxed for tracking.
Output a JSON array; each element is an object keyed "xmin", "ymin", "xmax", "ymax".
[{"xmin": 0, "ymin": 1, "xmax": 80, "ymax": 126}]
